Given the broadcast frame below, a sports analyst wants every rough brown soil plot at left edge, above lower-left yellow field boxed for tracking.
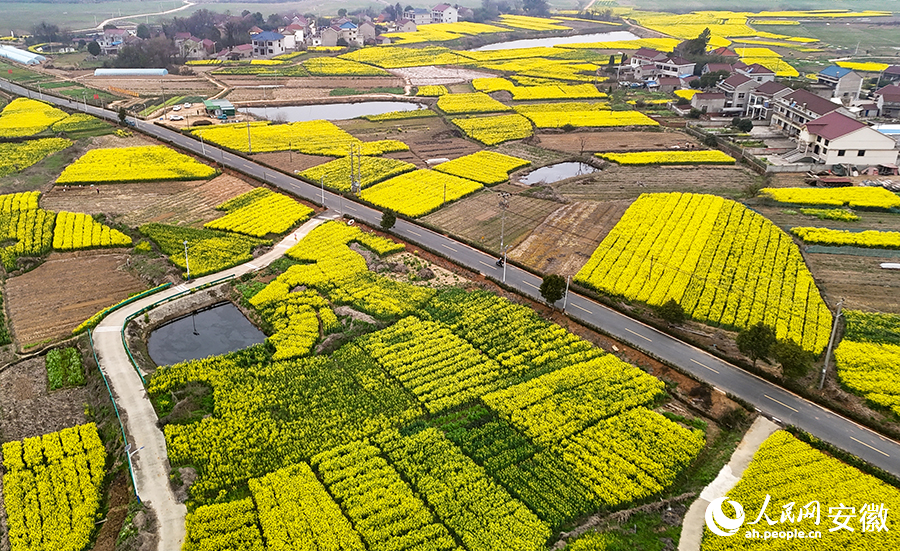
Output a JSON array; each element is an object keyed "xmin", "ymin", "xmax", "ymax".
[{"xmin": 0, "ymin": 356, "xmax": 92, "ymax": 442}]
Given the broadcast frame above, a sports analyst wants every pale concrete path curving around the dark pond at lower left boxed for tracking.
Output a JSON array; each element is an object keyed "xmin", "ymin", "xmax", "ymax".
[{"xmin": 93, "ymin": 215, "xmax": 336, "ymax": 551}]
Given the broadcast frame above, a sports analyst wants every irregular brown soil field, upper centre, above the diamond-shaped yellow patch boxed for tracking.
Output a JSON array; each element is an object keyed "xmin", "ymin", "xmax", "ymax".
[{"xmin": 335, "ymin": 117, "xmax": 483, "ymax": 167}]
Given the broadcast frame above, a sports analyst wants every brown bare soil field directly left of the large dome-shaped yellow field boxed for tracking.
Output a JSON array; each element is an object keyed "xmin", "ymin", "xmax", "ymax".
[{"xmin": 509, "ymin": 201, "xmax": 631, "ymax": 276}]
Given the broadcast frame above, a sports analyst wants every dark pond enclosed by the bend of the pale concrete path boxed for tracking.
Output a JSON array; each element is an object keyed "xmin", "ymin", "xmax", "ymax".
[{"xmin": 147, "ymin": 302, "xmax": 266, "ymax": 365}]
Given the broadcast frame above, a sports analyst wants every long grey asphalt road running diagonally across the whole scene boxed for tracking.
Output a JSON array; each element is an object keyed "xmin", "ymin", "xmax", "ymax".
[{"xmin": 0, "ymin": 81, "xmax": 900, "ymax": 476}]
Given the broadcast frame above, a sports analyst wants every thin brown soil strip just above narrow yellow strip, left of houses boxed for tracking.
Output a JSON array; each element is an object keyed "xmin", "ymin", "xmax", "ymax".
[{"xmin": 536, "ymin": 131, "xmax": 699, "ymax": 154}]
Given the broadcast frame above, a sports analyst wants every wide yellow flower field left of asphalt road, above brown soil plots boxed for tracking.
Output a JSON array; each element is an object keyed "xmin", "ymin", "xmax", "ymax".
[{"xmin": 56, "ymin": 145, "xmax": 216, "ymax": 185}]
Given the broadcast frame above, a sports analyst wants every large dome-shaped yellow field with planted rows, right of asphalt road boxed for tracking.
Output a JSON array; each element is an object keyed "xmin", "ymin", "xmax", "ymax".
[{"xmin": 575, "ymin": 193, "xmax": 832, "ymax": 354}]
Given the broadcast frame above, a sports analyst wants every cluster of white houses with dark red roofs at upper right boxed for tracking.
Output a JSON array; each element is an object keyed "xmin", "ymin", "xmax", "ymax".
[{"xmin": 617, "ymin": 47, "xmax": 900, "ymax": 172}]
